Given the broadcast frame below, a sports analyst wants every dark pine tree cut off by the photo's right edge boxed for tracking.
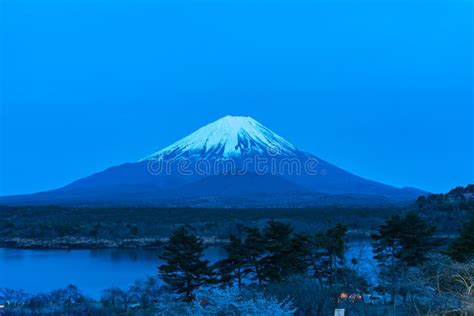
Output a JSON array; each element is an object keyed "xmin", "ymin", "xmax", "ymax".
[{"xmin": 447, "ymin": 218, "xmax": 474, "ymax": 262}]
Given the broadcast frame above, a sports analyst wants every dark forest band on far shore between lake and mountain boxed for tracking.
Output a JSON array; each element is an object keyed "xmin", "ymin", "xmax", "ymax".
[{"xmin": 0, "ymin": 190, "xmax": 474, "ymax": 248}]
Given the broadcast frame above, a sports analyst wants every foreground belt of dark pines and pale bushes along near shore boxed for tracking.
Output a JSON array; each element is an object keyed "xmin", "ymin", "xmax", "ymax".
[{"xmin": 0, "ymin": 213, "xmax": 474, "ymax": 315}]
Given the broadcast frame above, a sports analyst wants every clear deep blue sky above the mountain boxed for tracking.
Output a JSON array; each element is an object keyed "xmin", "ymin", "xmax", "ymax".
[{"xmin": 0, "ymin": 0, "xmax": 474, "ymax": 194}]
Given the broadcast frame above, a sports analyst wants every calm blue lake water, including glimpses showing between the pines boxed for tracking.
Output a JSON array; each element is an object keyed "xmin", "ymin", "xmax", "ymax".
[{"xmin": 0, "ymin": 242, "xmax": 375, "ymax": 298}]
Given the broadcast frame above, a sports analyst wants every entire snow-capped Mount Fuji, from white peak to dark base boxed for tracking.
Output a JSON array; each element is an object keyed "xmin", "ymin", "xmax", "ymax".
[{"xmin": 0, "ymin": 116, "xmax": 425, "ymax": 207}]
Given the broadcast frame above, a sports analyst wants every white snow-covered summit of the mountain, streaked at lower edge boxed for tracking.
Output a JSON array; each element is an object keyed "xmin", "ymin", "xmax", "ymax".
[{"xmin": 142, "ymin": 115, "xmax": 298, "ymax": 160}]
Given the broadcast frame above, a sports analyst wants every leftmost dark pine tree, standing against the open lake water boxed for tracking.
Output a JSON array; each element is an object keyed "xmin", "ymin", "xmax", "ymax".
[{"xmin": 159, "ymin": 227, "xmax": 212, "ymax": 301}]
